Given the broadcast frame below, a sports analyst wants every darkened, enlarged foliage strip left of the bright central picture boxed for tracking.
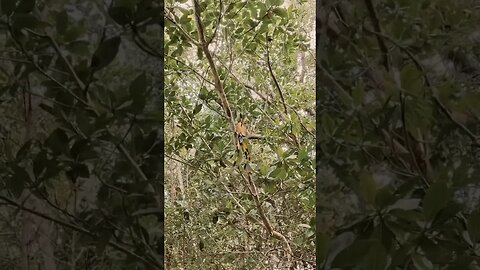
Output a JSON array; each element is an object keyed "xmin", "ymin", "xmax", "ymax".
[{"xmin": 0, "ymin": 0, "xmax": 164, "ymax": 270}]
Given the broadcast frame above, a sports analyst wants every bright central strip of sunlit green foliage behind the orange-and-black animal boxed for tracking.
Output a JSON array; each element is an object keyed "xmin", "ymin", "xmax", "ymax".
[{"xmin": 164, "ymin": 0, "xmax": 315, "ymax": 270}]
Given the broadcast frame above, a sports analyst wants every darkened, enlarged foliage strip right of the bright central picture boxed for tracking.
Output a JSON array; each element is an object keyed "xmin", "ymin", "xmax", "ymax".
[{"xmin": 317, "ymin": 0, "xmax": 480, "ymax": 270}]
